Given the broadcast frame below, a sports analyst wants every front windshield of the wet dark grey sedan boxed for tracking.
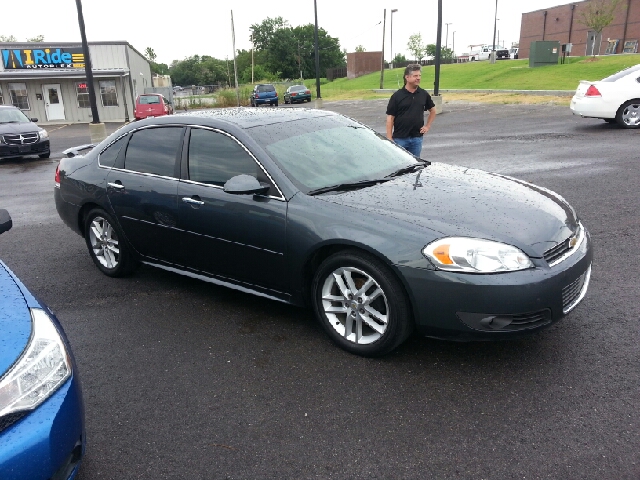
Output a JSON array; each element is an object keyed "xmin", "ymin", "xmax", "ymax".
[{"xmin": 250, "ymin": 115, "xmax": 420, "ymax": 193}]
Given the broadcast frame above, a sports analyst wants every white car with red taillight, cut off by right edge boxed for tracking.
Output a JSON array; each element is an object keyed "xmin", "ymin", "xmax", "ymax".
[{"xmin": 571, "ymin": 64, "xmax": 640, "ymax": 128}]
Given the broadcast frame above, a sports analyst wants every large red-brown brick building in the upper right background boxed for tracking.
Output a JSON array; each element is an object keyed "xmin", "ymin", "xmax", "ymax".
[{"xmin": 518, "ymin": 0, "xmax": 640, "ymax": 58}]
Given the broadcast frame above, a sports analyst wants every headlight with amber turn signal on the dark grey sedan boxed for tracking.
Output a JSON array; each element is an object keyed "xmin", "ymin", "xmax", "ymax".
[{"xmin": 422, "ymin": 237, "xmax": 533, "ymax": 273}]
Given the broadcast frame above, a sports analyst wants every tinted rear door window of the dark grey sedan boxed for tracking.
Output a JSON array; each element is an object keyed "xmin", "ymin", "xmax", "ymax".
[{"xmin": 124, "ymin": 127, "xmax": 182, "ymax": 177}]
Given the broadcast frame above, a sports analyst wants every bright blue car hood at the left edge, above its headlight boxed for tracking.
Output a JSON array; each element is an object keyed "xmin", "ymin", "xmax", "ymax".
[{"xmin": 0, "ymin": 261, "xmax": 33, "ymax": 377}]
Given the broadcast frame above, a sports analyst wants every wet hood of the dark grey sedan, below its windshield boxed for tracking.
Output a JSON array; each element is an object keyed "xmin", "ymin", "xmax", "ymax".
[{"xmin": 317, "ymin": 163, "xmax": 577, "ymax": 257}]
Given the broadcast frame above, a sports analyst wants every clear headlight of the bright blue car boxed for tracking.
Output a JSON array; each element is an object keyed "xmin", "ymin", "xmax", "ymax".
[{"xmin": 0, "ymin": 308, "xmax": 71, "ymax": 417}]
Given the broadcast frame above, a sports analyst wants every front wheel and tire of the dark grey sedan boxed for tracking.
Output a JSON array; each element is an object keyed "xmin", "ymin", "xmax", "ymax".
[{"xmin": 312, "ymin": 250, "xmax": 413, "ymax": 357}]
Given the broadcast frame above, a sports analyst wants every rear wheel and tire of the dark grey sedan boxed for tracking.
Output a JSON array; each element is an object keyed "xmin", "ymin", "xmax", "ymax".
[{"xmin": 84, "ymin": 208, "xmax": 137, "ymax": 277}]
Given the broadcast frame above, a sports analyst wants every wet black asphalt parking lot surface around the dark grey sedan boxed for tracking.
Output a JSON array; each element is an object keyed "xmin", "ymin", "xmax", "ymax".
[{"xmin": 0, "ymin": 101, "xmax": 640, "ymax": 480}]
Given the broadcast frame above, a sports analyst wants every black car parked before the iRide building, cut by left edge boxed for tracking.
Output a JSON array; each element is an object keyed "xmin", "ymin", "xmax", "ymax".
[{"xmin": 0, "ymin": 105, "xmax": 51, "ymax": 158}]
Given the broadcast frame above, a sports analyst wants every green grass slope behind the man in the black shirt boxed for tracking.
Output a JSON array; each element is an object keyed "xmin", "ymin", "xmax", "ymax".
[{"xmin": 321, "ymin": 54, "xmax": 640, "ymax": 93}]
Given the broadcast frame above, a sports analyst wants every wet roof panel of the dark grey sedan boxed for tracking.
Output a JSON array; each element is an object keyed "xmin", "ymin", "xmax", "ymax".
[{"xmin": 172, "ymin": 107, "xmax": 339, "ymax": 129}]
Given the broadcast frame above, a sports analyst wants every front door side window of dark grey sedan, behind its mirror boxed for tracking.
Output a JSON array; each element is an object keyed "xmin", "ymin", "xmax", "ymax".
[{"xmin": 189, "ymin": 128, "xmax": 258, "ymax": 186}]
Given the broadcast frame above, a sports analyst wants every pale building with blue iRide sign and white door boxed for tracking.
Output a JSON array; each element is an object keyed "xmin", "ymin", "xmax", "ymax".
[{"xmin": 0, "ymin": 41, "xmax": 152, "ymax": 124}]
